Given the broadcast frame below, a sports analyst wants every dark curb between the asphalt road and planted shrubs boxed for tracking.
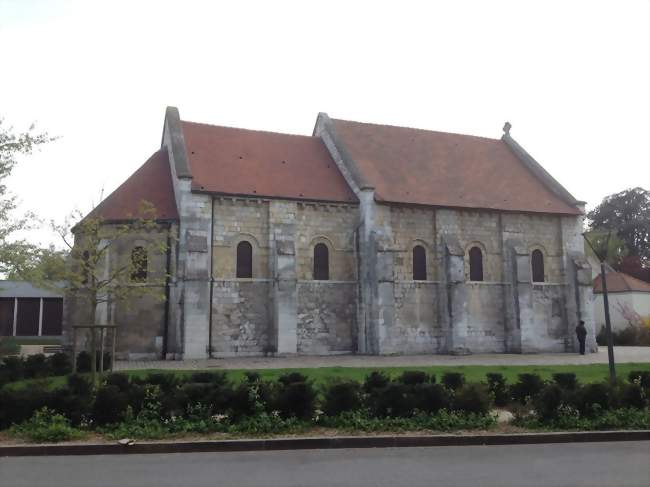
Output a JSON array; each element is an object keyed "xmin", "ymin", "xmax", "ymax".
[{"xmin": 0, "ymin": 430, "xmax": 650, "ymax": 457}]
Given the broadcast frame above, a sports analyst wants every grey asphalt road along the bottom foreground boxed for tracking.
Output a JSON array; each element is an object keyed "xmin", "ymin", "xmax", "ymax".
[{"xmin": 0, "ymin": 441, "xmax": 650, "ymax": 487}]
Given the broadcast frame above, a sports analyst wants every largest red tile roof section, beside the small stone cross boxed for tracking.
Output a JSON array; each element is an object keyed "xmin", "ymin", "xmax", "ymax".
[{"xmin": 332, "ymin": 120, "xmax": 580, "ymax": 215}]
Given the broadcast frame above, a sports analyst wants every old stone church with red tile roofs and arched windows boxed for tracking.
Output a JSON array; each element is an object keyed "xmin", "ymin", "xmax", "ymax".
[{"xmin": 64, "ymin": 107, "xmax": 596, "ymax": 359}]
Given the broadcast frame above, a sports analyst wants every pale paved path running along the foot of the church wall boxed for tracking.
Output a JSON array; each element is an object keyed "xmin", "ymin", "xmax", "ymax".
[{"xmin": 115, "ymin": 347, "xmax": 650, "ymax": 370}]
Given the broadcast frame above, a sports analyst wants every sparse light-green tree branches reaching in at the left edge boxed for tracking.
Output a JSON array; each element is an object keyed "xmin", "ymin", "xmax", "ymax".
[{"xmin": 0, "ymin": 118, "xmax": 55, "ymax": 274}]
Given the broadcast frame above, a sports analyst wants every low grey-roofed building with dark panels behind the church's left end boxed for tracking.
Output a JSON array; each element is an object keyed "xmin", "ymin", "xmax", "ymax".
[{"xmin": 0, "ymin": 281, "xmax": 63, "ymax": 353}]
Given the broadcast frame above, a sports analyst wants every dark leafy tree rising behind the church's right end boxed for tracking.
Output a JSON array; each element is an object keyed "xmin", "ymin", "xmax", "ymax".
[{"xmin": 587, "ymin": 187, "xmax": 650, "ymax": 265}]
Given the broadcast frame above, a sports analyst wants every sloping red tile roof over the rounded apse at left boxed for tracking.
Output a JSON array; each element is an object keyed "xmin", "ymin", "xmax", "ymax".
[{"xmin": 86, "ymin": 148, "xmax": 178, "ymax": 221}]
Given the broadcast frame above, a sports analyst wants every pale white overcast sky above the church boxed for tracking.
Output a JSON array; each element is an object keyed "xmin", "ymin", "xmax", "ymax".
[{"xmin": 0, "ymin": 0, "xmax": 650, "ymax": 248}]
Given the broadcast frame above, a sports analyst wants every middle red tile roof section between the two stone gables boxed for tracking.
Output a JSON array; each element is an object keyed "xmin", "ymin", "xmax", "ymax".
[{"xmin": 182, "ymin": 121, "xmax": 357, "ymax": 206}]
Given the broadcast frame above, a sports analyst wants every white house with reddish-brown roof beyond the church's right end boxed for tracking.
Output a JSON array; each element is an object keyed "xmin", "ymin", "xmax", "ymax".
[{"xmin": 594, "ymin": 272, "xmax": 650, "ymax": 331}]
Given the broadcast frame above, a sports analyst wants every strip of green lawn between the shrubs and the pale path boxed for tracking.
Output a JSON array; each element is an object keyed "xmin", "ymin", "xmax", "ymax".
[{"xmin": 5, "ymin": 363, "xmax": 650, "ymax": 388}]
